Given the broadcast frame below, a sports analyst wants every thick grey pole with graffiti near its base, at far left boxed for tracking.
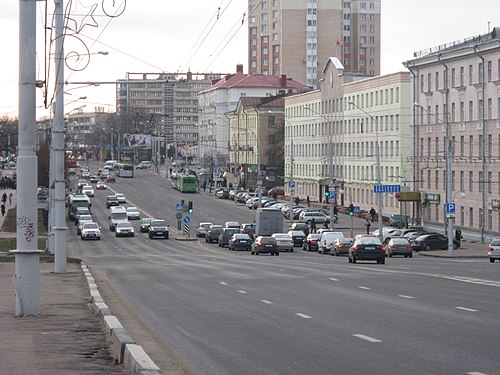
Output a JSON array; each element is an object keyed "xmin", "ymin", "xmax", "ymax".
[{"xmin": 11, "ymin": 0, "xmax": 40, "ymax": 316}]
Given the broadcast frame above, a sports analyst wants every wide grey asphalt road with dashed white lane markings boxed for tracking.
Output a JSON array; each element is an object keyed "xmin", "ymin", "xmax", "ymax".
[{"xmin": 69, "ymin": 171, "xmax": 500, "ymax": 375}]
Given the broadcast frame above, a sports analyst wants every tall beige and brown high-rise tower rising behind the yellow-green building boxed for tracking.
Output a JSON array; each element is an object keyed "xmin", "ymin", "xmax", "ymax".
[{"xmin": 248, "ymin": 0, "xmax": 381, "ymax": 88}]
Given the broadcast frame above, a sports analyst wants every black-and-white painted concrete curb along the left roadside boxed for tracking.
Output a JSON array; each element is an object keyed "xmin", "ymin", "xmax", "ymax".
[{"xmin": 81, "ymin": 262, "xmax": 161, "ymax": 375}]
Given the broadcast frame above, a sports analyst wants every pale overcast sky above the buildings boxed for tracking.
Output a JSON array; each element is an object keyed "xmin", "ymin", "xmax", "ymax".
[{"xmin": 0, "ymin": 0, "xmax": 500, "ymax": 116}]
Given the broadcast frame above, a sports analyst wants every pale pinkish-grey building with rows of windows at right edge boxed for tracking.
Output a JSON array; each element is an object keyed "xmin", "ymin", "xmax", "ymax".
[{"xmin": 405, "ymin": 27, "xmax": 500, "ymax": 239}]
